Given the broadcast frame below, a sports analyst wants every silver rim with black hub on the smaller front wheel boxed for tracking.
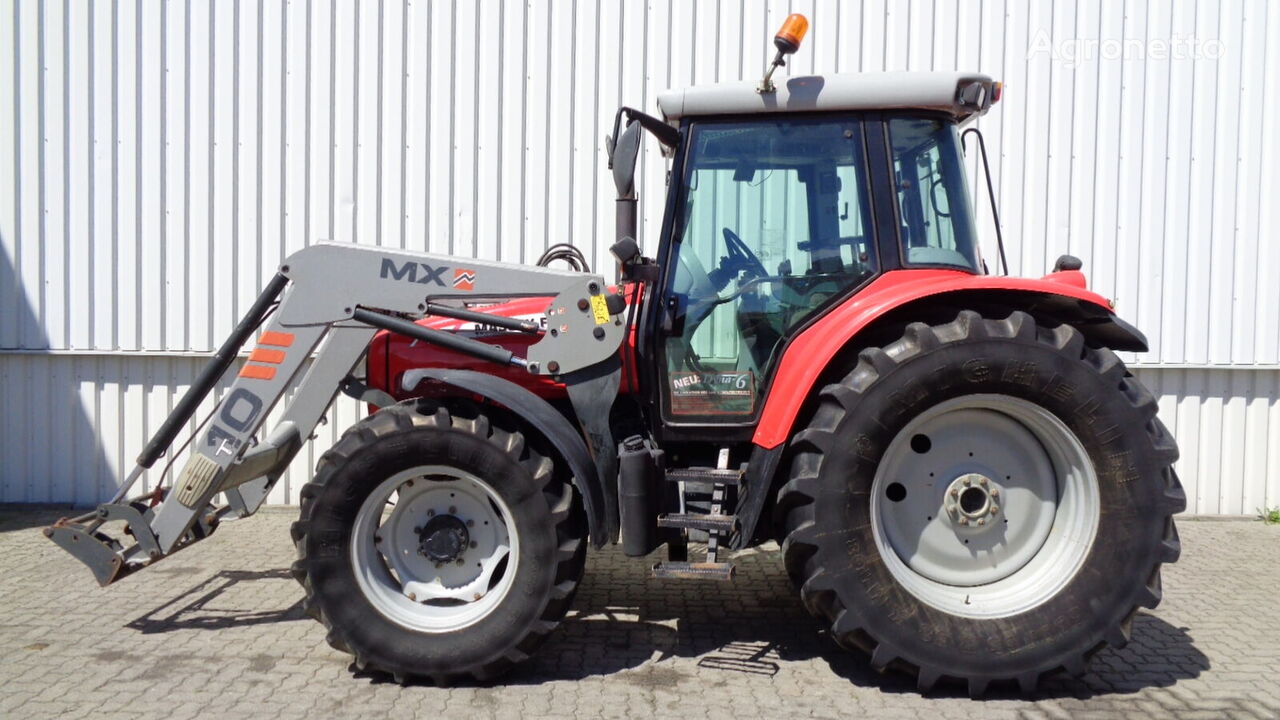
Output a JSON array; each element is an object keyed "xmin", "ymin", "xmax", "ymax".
[{"xmin": 351, "ymin": 465, "xmax": 520, "ymax": 633}]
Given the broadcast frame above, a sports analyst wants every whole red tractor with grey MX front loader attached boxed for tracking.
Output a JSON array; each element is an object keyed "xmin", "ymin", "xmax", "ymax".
[{"xmin": 45, "ymin": 15, "xmax": 1185, "ymax": 696}]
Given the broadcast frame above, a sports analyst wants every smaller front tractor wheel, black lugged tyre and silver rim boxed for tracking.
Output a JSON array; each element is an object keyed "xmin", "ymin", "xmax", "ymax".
[{"xmin": 293, "ymin": 400, "xmax": 586, "ymax": 683}]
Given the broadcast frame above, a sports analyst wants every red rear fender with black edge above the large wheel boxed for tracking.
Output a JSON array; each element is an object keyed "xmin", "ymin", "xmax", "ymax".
[{"xmin": 751, "ymin": 270, "xmax": 1147, "ymax": 448}]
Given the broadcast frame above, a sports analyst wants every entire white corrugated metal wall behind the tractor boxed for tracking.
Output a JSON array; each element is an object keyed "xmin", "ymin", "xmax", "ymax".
[{"xmin": 0, "ymin": 0, "xmax": 1280, "ymax": 512}]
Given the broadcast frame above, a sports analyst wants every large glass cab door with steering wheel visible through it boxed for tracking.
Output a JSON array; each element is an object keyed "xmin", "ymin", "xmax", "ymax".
[{"xmin": 664, "ymin": 117, "xmax": 876, "ymax": 421}]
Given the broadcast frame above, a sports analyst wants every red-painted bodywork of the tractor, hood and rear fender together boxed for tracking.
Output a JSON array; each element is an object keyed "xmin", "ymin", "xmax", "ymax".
[{"xmin": 367, "ymin": 270, "xmax": 1111, "ymax": 448}]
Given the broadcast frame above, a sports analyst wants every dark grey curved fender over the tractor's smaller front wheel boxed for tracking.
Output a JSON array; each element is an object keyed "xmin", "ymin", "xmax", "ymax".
[{"xmin": 402, "ymin": 368, "xmax": 609, "ymax": 548}]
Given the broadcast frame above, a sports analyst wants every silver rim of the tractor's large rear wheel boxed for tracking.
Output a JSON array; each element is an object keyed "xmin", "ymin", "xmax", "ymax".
[{"xmin": 870, "ymin": 395, "xmax": 1101, "ymax": 618}]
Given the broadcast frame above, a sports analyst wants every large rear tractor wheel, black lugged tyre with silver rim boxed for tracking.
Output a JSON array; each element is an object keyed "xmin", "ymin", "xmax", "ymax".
[{"xmin": 778, "ymin": 311, "xmax": 1185, "ymax": 694}]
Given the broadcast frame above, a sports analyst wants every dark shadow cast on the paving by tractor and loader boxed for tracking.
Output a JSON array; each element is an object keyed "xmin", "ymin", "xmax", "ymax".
[{"xmin": 115, "ymin": 540, "xmax": 1210, "ymax": 700}]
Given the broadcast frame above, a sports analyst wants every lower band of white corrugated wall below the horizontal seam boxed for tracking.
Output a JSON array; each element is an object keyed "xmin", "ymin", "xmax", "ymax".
[{"xmin": 0, "ymin": 355, "xmax": 1280, "ymax": 515}]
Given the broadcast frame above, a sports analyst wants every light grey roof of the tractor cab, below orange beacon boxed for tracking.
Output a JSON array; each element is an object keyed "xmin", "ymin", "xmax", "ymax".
[{"xmin": 658, "ymin": 72, "xmax": 995, "ymax": 124}]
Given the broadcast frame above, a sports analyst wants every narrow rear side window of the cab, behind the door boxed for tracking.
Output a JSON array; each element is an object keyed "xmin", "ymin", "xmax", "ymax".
[{"xmin": 888, "ymin": 118, "xmax": 982, "ymax": 273}]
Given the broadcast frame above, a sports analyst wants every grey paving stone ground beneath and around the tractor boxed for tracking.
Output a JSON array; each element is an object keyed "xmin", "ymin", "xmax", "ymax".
[{"xmin": 0, "ymin": 509, "xmax": 1280, "ymax": 720}]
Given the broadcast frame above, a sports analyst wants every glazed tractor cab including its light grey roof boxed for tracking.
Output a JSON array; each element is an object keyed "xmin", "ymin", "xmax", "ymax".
[{"xmin": 620, "ymin": 73, "xmax": 998, "ymax": 436}]
